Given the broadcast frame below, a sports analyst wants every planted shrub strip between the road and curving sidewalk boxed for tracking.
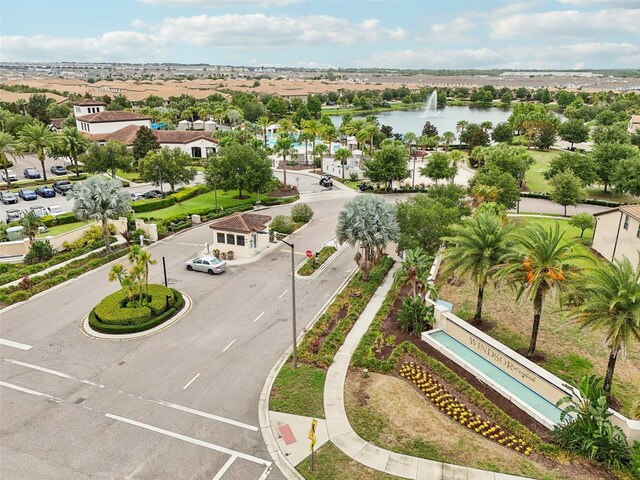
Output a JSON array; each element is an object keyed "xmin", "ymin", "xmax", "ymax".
[{"xmin": 298, "ymin": 257, "xmax": 393, "ymax": 367}]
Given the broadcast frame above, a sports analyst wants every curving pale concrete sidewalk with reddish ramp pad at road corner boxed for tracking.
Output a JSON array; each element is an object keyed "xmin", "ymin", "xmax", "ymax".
[{"xmin": 259, "ymin": 263, "xmax": 536, "ymax": 480}]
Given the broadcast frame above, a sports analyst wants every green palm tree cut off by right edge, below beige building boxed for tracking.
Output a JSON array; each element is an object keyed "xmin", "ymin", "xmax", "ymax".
[{"xmin": 569, "ymin": 257, "xmax": 640, "ymax": 395}]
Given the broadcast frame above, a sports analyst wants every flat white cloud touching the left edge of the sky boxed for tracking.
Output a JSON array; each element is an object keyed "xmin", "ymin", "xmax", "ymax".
[{"xmin": 0, "ymin": 31, "xmax": 167, "ymax": 62}]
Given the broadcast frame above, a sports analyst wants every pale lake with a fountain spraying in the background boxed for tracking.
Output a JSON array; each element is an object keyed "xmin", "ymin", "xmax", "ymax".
[{"xmin": 331, "ymin": 106, "xmax": 511, "ymax": 136}]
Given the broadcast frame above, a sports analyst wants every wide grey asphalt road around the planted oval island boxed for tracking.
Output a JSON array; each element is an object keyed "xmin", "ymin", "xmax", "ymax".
[{"xmin": 0, "ymin": 191, "xmax": 354, "ymax": 480}]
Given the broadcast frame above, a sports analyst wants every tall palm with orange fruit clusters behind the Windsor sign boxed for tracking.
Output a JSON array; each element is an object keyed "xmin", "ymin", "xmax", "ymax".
[{"xmin": 497, "ymin": 223, "xmax": 590, "ymax": 357}]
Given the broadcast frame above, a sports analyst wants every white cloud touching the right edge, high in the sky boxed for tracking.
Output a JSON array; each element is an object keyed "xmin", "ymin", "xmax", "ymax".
[{"xmin": 489, "ymin": 9, "xmax": 640, "ymax": 40}]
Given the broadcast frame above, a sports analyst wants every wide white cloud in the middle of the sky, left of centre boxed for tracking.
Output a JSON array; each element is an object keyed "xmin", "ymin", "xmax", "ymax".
[{"xmin": 151, "ymin": 13, "xmax": 406, "ymax": 48}]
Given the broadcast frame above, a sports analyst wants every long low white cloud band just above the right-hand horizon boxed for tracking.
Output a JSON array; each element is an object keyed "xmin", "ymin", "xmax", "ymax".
[{"xmin": 357, "ymin": 42, "xmax": 640, "ymax": 69}]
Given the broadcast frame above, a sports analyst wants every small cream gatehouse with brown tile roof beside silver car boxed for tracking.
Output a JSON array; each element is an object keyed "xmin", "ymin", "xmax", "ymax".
[{"xmin": 209, "ymin": 212, "xmax": 271, "ymax": 258}]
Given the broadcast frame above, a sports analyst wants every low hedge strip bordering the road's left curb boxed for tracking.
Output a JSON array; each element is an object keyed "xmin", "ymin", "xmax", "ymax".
[{"xmin": 0, "ymin": 248, "xmax": 128, "ymax": 305}]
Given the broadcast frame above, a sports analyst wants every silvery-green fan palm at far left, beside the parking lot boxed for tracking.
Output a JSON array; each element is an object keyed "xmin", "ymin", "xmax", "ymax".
[{"xmin": 69, "ymin": 175, "xmax": 131, "ymax": 252}]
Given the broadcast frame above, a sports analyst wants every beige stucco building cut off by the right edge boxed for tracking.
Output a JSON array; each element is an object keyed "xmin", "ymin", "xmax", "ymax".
[{"xmin": 591, "ymin": 205, "xmax": 640, "ymax": 267}]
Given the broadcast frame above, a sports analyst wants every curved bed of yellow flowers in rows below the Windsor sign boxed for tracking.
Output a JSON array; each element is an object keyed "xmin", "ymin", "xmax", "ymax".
[{"xmin": 400, "ymin": 362, "xmax": 532, "ymax": 455}]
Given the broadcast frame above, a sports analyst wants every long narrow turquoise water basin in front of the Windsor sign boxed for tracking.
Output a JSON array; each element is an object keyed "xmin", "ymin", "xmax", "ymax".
[{"xmin": 427, "ymin": 330, "xmax": 562, "ymax": 425}]
